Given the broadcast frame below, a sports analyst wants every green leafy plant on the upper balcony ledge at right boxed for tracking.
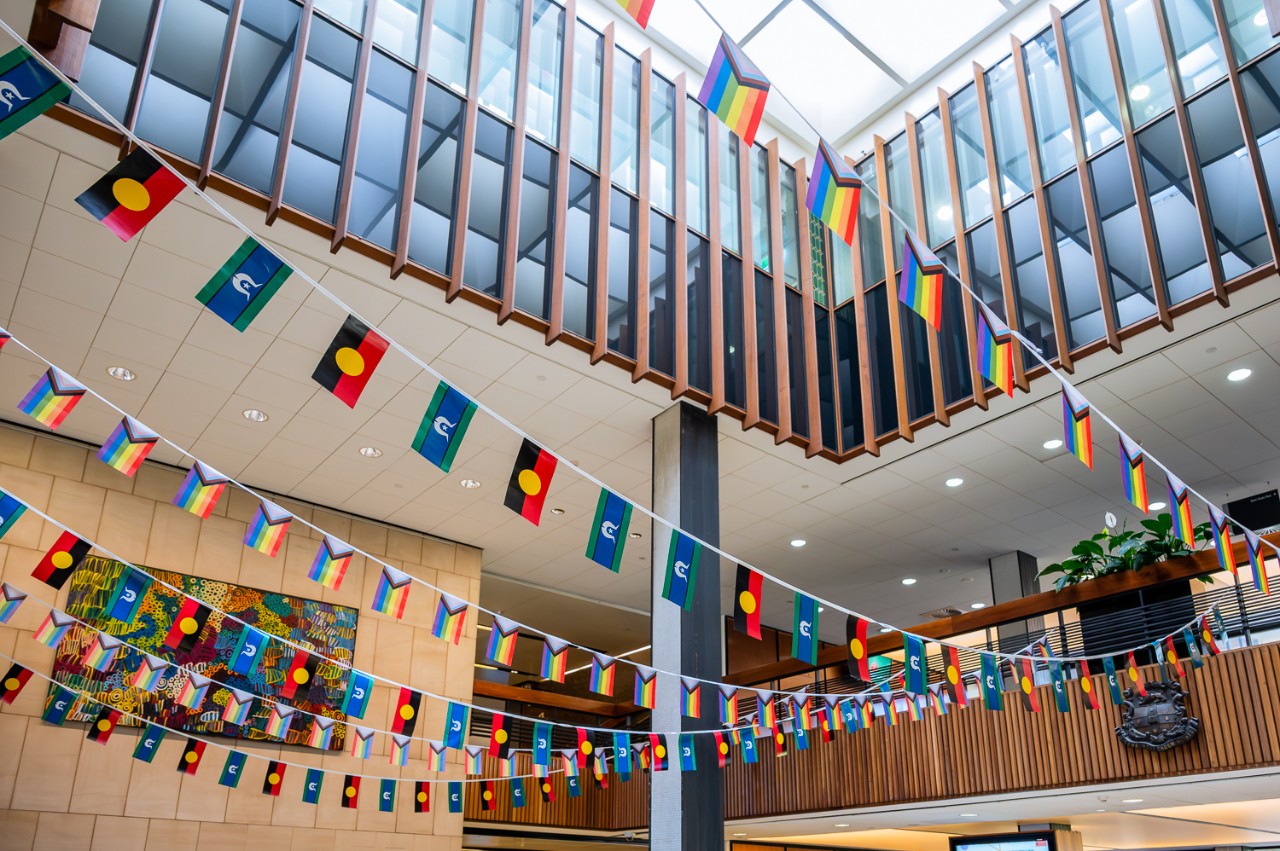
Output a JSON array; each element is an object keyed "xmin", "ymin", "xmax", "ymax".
[{"xmin": 1039, "ymin": 514, "xmax": 1213, "ymax": 591}]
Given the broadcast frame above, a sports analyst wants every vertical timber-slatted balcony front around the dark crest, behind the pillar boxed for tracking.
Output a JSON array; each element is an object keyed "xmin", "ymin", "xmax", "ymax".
[{"xmin": 466, "ymin": 644, "xmax": 1280, "ymax": 831}]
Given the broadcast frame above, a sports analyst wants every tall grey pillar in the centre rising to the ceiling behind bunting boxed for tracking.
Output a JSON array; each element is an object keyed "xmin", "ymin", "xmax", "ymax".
[{"xmin": 649, "ymin": 402, "xmax": 724, "ymax": 851}]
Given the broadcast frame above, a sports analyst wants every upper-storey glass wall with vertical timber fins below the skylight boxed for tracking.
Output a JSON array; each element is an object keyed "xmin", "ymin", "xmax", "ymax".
[{"xmin": 22, "ymin": 0, "xmax": 1280, "ymax": 461}]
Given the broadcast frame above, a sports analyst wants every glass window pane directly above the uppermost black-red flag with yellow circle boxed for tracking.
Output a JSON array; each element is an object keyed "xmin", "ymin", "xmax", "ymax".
[{"xmin": 137, "ymin": 0, "xmax": 227, "ymax": 163}]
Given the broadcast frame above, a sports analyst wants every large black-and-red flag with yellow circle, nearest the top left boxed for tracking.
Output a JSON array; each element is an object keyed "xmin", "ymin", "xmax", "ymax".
[{"xmin": 76, "ymin": 148, "xmax": 186, "ymax": 242}]
